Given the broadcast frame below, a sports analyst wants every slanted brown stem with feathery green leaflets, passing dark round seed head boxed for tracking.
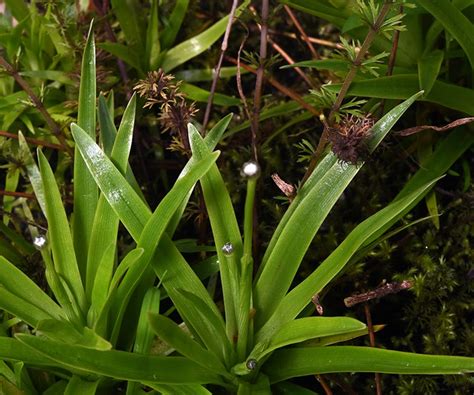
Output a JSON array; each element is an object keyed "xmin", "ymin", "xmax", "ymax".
[{"xmin": 302, "ymin": 2, "xmax": 392, "ymax": 184}]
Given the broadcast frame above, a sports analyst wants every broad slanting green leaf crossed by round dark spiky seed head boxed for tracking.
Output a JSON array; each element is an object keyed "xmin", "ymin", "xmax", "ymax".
[{"xmin": 254, "ymin": 93, "xmax": 421, "ymax": 328}]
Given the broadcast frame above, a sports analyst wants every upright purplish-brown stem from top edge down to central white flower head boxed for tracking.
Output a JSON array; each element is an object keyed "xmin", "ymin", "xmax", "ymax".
[{"xmin": 251, "ymin": 0, "xmax": 270, "ymax": 162}]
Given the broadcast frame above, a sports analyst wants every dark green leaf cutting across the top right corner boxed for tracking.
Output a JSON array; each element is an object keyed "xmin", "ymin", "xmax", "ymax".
[{"xmin": 418, "ymin": 0, "xmax": 474, "ymax": 68}]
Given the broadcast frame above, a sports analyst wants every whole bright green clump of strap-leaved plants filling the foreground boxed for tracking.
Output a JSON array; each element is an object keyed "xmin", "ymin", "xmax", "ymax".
[{"xmin": 0, "ymin": 24, "xmax": 474, "ymax": 394}]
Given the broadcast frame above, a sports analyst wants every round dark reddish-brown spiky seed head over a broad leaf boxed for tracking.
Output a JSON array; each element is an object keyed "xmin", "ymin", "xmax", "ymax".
[{"xmin": 329, "ymin": 115, "xmax": 374, "ymax": 164}]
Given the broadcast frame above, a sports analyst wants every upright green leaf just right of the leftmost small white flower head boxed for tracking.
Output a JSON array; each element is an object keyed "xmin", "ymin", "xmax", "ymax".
[{"xmin": 38, "ymin": 150, "xmax": 87, "ymax": 321}]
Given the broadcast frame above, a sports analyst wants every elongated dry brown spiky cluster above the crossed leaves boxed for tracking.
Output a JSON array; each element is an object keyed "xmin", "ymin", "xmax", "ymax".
[{"xmin": 134, "ymin": 69, "xmax": 197, "ymax": 153}]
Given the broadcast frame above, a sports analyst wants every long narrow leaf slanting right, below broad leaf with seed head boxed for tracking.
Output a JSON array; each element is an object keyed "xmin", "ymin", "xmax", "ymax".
[{"xmin": 257, "ymin": 179, "xmax": 437, "ymax": 341}]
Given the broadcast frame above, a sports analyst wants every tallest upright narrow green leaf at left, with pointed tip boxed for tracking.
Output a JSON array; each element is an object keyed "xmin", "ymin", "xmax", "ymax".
[{"xmin": 72, "ymin": 23, "xmax": 99, "ymax": 284}]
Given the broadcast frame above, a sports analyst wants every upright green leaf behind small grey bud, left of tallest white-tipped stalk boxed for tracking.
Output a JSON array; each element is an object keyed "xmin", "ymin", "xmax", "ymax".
[{"xmin": 188, "ymin": 124, "xmax": 243, "ymax": 339}]
